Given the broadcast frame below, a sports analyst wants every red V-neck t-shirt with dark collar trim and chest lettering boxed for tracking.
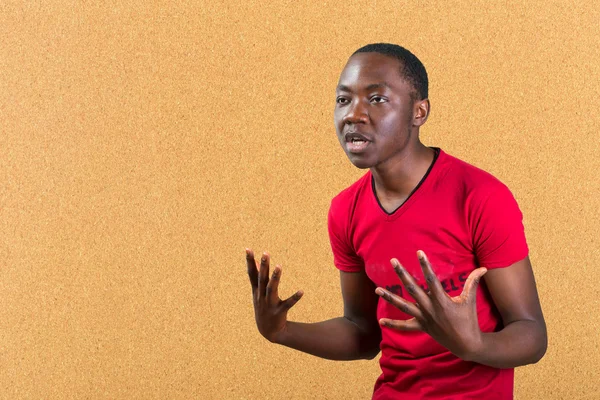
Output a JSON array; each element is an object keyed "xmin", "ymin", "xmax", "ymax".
[{"xmin": 328, "ymin": 149, "xmax": 528, "ymax": 400}]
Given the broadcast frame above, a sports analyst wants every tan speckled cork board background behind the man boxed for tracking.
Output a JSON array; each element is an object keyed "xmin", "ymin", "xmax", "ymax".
[{"xmin": 0, "ymin": 0, "xmax": 600, "ymax": 399}]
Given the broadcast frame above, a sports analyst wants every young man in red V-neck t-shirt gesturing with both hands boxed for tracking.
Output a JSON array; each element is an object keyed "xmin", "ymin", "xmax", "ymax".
[{"xmin": 246, "ymin": 44, "xmax": 547, "ymax": 399}]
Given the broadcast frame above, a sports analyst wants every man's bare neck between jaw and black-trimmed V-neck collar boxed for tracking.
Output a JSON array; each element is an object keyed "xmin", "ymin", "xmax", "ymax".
[{"xmin": 371, "ymin": 141, "xmax": 434, "ymax": 198}]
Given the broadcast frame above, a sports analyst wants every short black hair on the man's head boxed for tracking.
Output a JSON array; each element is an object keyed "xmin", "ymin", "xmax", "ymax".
[{"xmin": 352, "ymin": 43, "xmax": 429, "ymax": 100}]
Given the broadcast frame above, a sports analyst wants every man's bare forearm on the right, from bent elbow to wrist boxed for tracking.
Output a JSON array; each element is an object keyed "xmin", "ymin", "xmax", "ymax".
[{"xmin": 465, "ymin": 320, "xmax": 548, "ymax": 368}]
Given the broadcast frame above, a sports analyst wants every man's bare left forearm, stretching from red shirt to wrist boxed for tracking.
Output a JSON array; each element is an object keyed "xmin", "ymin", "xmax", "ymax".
[{"xmin": 276, "ymin": 317, "xmax": 381, "ymax": 360}]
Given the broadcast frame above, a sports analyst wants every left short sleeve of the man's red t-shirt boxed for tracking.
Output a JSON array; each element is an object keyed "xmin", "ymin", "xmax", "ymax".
[{"xmin": 327, "ymin": 199, "xmax": 364, "ymax": 272}]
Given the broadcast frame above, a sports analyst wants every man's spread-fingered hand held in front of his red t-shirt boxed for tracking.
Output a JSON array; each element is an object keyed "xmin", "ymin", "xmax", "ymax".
[{"xmin": 375, "ymin": 250, "xmax": 487, "ymax": 359}]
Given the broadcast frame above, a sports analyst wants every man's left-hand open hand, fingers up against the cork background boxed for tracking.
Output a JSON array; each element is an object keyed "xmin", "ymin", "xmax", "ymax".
[{"xmin": 246, "ymin": 249, "xmax": 303, "ymax": 343}]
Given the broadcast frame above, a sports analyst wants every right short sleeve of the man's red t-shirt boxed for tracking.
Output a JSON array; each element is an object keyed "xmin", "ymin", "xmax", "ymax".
[{"xmin": 471, "ymin": 184, "xmax": 529, "ymax": 269}]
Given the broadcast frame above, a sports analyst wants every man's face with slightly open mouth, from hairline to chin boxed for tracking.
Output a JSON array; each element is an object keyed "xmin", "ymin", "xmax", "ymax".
[{"xmin": 334, "ymin": 53, "xmax": 422, "ymax": 168}]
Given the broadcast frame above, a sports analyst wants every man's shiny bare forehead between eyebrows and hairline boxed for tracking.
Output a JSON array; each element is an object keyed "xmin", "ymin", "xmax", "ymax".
[{"xmin": 338, "ymin": 53, "xmax": 406, "ymax": 90}]
